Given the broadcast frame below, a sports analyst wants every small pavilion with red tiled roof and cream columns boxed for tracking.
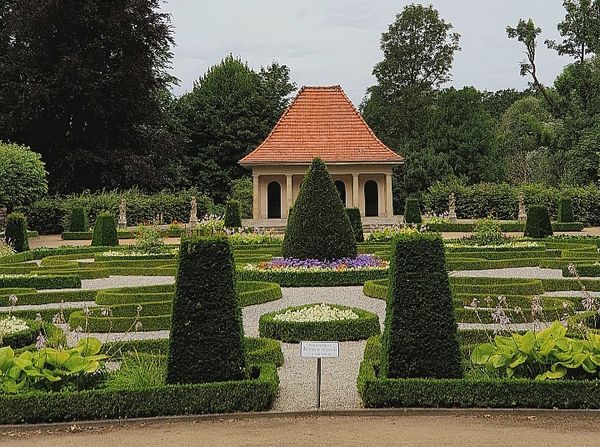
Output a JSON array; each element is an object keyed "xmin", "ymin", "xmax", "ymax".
[{"xmin": 240, "ymin": 85, "xmax": 404, "ymax": 227}]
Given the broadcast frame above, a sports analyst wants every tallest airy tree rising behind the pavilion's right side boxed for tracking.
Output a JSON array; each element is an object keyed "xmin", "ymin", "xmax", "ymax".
[{"xmin": 361, "ymin": 5, "xmax": 460, "ymax": 207}]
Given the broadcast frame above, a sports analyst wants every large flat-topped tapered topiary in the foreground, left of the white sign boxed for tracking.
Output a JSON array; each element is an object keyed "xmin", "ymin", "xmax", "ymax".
[{"xmin": 167, "ymin": 237, "xmax": 245, "ymax": 383}]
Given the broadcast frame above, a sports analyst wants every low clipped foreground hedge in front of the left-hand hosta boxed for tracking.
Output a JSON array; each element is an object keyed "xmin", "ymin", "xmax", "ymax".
[{"xmin": 0, "ymin": 364, "xmax": 279, "ymax": 424}]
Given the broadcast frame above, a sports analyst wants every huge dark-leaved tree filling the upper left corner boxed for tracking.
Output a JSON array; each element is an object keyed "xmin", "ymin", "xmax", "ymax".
[{"xmin": 0, "ymin": 0, "xmax": 175, "ymax": 192}]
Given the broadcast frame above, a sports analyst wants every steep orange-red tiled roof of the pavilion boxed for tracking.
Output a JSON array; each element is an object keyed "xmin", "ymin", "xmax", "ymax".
[{"xmin": 240, "ymin": 85, "xmax": 404, "ymax": 166}]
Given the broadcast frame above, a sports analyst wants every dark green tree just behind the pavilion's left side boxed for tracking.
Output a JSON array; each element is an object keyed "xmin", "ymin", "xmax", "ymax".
[{"xmin": 175, "ymin": 55, "xmax": 295, "ymax": 201}]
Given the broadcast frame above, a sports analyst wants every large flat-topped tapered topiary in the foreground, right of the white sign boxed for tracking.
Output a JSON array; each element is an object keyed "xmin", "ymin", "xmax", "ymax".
[{"xmin": 380, "ymin": 232, "xmax": 462, "ymax": 378}]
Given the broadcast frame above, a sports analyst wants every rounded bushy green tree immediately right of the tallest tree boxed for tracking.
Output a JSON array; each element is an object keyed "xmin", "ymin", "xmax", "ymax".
[{"xmin": 426, "ymin": 87, "xmax": 494, "ymax": 183}]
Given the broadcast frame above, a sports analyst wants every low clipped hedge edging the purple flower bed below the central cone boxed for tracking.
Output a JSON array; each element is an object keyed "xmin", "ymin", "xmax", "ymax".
[{"xmin": 237, "ymin": 269, "xmax": 388, "ymax": 287}]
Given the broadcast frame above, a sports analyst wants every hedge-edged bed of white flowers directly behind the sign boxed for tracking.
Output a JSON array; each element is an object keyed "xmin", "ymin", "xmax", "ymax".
[{"xmin": 259, "ymin": 304, "xmax": 380, "ymax": 343}]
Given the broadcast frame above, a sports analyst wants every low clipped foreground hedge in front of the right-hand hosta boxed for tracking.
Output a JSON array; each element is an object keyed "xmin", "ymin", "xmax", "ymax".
[{"xmin": 357, "ymin": 332, "xmax": 600, "ymax": 409}]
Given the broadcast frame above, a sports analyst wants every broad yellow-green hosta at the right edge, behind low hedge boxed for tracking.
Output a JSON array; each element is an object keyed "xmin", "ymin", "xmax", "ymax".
[{"xmin": 471, "ymin": 321, "xmax": 600, "ymax": 380}]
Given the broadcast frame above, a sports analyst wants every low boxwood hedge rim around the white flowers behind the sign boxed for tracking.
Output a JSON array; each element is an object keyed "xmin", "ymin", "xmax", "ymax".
[{"xmin": 258, "ymin": 303, "xmax": 380, "ymax": 343}]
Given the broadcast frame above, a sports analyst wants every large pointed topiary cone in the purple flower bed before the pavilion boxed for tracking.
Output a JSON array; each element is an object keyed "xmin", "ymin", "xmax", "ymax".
[{"xmin": 283, "ymin": 158, "xmax": 356, "ymax": 261}]
